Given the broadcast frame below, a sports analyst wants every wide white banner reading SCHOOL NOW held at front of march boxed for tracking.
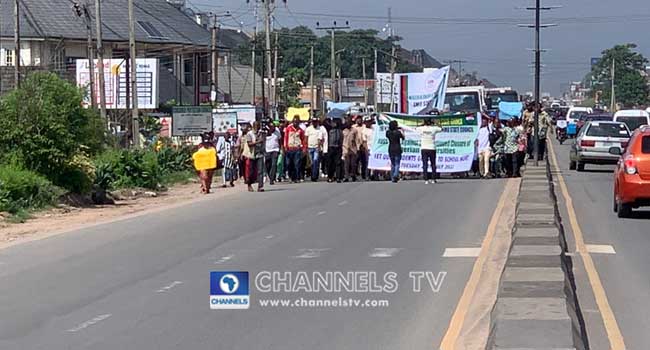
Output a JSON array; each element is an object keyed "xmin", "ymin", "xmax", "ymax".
[{"xmin": 368, "ymin": 113, "xmax": 480, "ymax": 173}]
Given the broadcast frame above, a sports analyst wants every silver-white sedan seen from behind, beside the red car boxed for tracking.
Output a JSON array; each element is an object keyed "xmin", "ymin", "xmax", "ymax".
[{"xmin": 569, "ymin": 121, "xmax": 630, "ymax": 171}]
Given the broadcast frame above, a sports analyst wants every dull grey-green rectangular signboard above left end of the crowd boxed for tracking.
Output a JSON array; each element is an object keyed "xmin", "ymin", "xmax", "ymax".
[{"xmin": 172, "ymin": 106, "xmax": 212, "ymax": 136}]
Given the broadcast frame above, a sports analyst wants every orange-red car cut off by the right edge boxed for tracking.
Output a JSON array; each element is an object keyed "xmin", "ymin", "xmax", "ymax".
[{"xmin": 610, "ymin": 126, "xmax": 650, "ymax": 218}]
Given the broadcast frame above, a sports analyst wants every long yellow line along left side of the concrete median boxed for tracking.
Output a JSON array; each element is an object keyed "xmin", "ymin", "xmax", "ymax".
[{"xmin": 439, "ymin": 179, "xmax": 517, "ymax": 350}]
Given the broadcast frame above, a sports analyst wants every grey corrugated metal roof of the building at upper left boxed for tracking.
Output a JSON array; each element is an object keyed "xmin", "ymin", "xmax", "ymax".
[{"xmin": 0, "ymin": 0, "xmax": 245, "ymax": 47}]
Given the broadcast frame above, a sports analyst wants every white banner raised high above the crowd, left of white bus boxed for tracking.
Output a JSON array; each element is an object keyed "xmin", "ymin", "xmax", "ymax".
[{"xmin": 399, "ymin": 66, "xmax": 449, "ymax": 115}]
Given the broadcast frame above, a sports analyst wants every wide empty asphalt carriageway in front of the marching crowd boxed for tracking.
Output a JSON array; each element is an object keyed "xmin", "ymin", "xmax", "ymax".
[{"xmin": 0, "ymin": 178, "xmax": 504, "ymax": 350}]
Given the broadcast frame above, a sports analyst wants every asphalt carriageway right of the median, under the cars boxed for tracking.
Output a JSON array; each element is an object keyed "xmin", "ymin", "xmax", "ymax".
[{"xmin": 554, "ymin": 140, "xmax": 650, "ymax": 350}]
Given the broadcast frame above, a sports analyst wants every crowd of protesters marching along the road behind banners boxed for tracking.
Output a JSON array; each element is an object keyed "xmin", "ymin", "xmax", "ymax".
[{"xmin": 192, "ymin": 104, "xmax": 552, "ymax": 193}]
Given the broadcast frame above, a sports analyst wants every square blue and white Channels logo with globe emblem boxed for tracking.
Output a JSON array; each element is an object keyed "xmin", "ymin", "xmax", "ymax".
[{"xmin": 210, "ymin": 271, "xmax": 250, "ymax": 310}]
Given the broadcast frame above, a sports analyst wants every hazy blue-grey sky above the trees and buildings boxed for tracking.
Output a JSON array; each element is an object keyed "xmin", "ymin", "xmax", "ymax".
[{"xmin": 188, "ymin": 0, "xmax": 650, "ymax": 96}]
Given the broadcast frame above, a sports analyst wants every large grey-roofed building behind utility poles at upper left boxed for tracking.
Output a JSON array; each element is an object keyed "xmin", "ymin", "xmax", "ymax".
[{"xmin": 0, "ymin": 0, "xmax": 262, "ymax": 108}]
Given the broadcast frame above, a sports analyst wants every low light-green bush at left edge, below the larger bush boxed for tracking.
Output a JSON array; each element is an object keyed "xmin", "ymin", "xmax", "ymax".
[{"xmin": 0, "ymin": 165, "xmax": 63, "ymax": 214}]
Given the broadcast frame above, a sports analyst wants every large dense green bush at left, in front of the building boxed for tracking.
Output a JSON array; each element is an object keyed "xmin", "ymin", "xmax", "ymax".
[{"xmin": 0, "ymin": 72, "xmax": 106, "ymax": 192}]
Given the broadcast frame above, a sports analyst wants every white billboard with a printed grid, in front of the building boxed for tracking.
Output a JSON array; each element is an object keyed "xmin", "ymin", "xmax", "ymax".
[{"xmin": 76, "ymin": 58, "xmax": 159, "ymax": 109}]
